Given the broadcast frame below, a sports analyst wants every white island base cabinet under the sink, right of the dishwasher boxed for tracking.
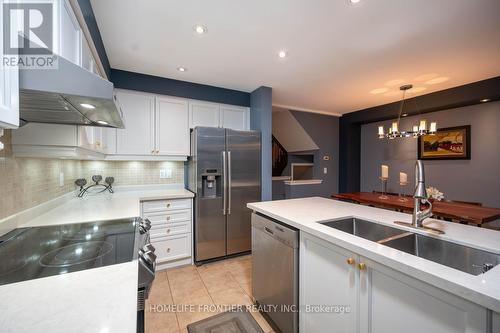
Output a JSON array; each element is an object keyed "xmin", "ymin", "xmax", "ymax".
[{"xmin": 299, "ymin": 233, "xmax": 488, "ymax": 333}]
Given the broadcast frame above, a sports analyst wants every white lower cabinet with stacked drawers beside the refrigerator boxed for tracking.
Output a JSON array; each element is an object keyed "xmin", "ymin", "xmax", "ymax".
[{"xmin": 142, "ymin": 199, "xmax": 193, "ymax": 270}]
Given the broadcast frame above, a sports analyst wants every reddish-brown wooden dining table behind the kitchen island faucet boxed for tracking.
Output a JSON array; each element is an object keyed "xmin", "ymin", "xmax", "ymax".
[{"xmin": 332, "ymin": 192, "xmax": 500, "ymax": 226}]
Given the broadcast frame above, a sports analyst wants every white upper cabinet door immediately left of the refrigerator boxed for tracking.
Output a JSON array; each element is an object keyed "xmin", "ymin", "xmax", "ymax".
[{"xmin": 156, "ymin": 96, "xmax": 189, "ymax": 156}]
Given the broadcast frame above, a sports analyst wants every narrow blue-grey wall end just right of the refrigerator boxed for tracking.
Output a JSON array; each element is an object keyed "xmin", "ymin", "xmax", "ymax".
[{"xmin": 250, "ymin": 87, "xmax": 273, "ymax": 201}]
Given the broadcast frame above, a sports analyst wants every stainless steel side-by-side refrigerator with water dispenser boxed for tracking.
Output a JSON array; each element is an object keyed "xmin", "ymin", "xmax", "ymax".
[{"xmin": 188, "ymin": 127, "xmax": 261, "ymax": 263}]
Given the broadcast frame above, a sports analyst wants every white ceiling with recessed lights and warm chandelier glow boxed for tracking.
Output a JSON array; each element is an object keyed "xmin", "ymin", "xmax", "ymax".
[{"xmin": 91, "ymin": 0, "xmax": 500, "ymax": 114}]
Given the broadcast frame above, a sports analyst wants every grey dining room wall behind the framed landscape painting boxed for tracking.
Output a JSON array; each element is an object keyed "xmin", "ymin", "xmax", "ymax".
[{"xmin": 361, "ymin": 102, "xmax": 500, "ymax": 208}]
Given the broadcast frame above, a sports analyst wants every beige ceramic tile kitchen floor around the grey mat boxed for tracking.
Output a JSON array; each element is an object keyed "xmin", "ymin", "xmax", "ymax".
[{"xmin": 146, "ymin": 256, "xmax": 273, "ymax": 333}]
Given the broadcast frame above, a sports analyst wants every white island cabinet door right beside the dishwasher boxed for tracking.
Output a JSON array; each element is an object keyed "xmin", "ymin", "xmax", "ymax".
[{"xmin": 299, "ymin": 232, "xmax": 358, "ymax": 333}]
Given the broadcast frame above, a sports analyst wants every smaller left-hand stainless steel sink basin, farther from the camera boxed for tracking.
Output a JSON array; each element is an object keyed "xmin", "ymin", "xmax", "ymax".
[{"xmin": 319, "ymin": 217, "xmax": 405, "ymax": 242}]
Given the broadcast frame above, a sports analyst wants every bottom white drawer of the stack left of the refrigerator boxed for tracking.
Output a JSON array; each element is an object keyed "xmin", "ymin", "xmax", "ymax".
[{"xmin": 151, "ymin": 234, "xmax": 191, "ymax": 263}]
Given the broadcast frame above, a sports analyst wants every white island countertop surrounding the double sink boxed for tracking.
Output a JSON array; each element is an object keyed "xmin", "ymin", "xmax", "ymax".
[{"xmin": 247, "ymin": 197, "xmax": 500, "ymax": 313}]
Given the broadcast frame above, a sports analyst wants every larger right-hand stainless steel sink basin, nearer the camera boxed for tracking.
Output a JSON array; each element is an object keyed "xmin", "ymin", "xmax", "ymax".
[{"xmin": 382, "ymin": 234, "xmax": 500, "ymax": 275}]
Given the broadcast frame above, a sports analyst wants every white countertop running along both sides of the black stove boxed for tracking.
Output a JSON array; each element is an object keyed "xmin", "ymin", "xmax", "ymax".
[{"xmin": 0, "ymin": 186, "xmax": 193, "ymax": 333}]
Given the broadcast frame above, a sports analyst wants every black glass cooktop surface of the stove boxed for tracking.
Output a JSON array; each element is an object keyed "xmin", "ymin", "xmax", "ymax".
[{"xmin": 0, "ymin": 219, "xmax": 139, "ymax": 285}]
